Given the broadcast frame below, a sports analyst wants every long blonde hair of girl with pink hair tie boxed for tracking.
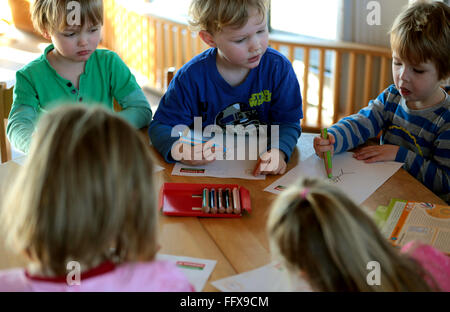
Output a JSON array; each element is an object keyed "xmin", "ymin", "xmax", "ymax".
[{"xmin": 268, "ymin": 178, "xmax": 440, "ymax": 291}]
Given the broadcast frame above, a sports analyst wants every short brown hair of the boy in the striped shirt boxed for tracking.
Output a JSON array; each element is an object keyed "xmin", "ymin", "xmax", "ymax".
[{"xmin": 390, "ymin": 1, "xmax": 450, "ymax": 80}]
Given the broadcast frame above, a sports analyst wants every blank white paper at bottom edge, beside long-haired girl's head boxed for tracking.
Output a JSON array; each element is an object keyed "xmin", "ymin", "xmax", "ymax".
[{"xmin": 211, "ymin": 261, "xmax": 311, "ymax": 292}]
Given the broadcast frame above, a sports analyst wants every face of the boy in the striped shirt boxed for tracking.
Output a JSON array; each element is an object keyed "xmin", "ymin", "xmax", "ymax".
[{"xmin": 392, "ymin": 52, "xmax": 441, "ymax": 103}]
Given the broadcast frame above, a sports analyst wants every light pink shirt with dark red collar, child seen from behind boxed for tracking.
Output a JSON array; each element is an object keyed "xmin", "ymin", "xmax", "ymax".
[{"xmin": 0, "ymin": 261, "xmax": 194, "ymax": 292}]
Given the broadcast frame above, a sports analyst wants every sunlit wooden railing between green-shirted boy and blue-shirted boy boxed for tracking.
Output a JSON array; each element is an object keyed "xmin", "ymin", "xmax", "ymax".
[{"xmin": 102, "ymin": 0, "xmax": 207, "ymax": 92}]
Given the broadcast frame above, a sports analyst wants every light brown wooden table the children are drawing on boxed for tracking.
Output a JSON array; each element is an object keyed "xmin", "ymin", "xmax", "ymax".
[{"xmin": 0, "ymin": 132, "xmax": 445, "ymax": 291}]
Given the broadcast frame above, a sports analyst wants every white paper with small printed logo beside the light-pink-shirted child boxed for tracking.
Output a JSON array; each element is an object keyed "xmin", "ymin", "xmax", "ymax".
[{"xmin": 156, "ymin": 254, "xmax": 217, "ymax": 291}]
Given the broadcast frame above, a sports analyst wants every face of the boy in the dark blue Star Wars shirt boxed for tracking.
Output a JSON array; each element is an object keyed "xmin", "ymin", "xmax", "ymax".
[{"xmin": 213, "ymin": 9, "xmax": 269, "ymax": 69}]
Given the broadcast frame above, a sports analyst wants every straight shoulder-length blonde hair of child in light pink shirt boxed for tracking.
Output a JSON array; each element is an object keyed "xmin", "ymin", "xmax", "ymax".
[{"xmin": 0, "ymin": 105, "xmax": 157, "ymax": 276}]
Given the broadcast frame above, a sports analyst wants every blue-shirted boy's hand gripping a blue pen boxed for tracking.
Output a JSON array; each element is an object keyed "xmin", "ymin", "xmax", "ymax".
[{"xmin": 172, "ymin": 140, "xmax": 218, "ymax": 166}]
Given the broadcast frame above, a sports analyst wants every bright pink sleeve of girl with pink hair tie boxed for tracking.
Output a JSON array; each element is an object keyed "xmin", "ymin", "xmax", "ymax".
[{"xmin": 402, "ymin": 241, "xmax": 450, "ymax": 292}]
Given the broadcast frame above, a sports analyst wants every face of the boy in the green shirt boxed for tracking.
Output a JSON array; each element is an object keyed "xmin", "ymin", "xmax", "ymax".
[{"xmin": 50, "ymin": 23, "xmax": 102, "ymax": 62}]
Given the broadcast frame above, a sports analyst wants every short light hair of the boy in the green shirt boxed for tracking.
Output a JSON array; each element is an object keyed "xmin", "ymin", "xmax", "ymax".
[{"xmin": 31, "ymin": 0, "xmax": 103, "ymax": 34}]
